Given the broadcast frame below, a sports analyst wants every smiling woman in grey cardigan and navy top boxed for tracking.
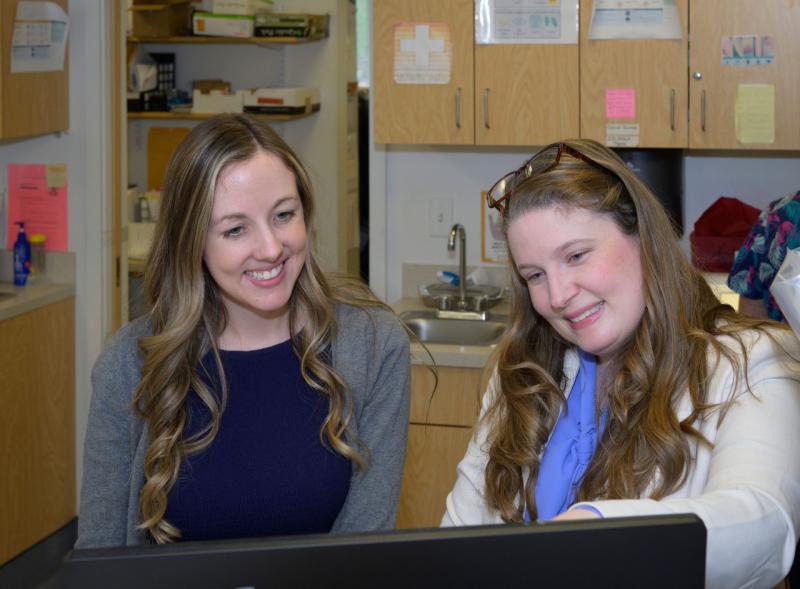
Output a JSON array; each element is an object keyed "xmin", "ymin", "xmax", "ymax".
[{"xmin": 76, "ymin": 115, "xmax": 409, "ymax": 548}]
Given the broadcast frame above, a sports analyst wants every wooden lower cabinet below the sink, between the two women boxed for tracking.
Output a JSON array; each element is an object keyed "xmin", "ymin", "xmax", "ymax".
[{"xmin": 397, "ymin": 365, "xmax": 484, "ymax": 528}]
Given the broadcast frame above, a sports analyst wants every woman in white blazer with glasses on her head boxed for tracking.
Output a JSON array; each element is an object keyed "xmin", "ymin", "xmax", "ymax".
[{"xmin": 443, "ymin": 140, "xmax": 800, "ymax": 589}]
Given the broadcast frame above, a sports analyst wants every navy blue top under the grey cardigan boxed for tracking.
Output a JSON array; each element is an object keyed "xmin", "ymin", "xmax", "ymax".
[{"xmin": 165, "ymin": 340, "xmax": 351, "ymax": 540}]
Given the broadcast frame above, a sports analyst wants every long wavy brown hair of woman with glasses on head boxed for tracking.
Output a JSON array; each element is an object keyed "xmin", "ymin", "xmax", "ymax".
[{"xmin": 484, "ymin": 140, "xmax": 777, "ymax": 522}]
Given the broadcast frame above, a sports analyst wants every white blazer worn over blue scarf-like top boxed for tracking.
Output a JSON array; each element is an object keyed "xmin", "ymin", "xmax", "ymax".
[{"xmin": 442, "ymin": 331, "xmax": 800, "ymax": 589}]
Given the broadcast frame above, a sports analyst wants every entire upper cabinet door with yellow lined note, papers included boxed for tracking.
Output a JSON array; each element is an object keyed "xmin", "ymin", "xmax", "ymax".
[{"xmin": 689, "ymin": 0, "xmax": 800, "ymax": 149}]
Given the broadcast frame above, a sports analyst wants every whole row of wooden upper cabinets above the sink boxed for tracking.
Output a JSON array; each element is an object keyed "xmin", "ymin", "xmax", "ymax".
[{"xmin": 373, "ymin": 0, "xmax": 800, "ymax": 150}]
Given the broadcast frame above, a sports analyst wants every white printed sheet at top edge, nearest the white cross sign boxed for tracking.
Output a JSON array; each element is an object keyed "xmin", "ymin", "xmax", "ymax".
[{"xmin": 475, "ymin": 0, "xmax": 578, "ymax": 45}]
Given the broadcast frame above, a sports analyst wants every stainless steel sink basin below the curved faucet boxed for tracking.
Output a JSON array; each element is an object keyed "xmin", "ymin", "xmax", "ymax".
[{"xmin": 400, "ymin": 309, "xmax": 508, "ymax": 346}]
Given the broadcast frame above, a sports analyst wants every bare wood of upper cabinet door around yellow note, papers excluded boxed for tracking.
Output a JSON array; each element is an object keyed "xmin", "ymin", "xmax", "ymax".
[{"xmin": 689, "ymin": 0, "xmax": 800, "ymax": 149}]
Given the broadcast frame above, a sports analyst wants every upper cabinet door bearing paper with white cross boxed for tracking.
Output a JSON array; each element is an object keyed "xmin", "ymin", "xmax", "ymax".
[{"xmin": 372, "ymin": 0, "xmax": 475, "ymax": 144}]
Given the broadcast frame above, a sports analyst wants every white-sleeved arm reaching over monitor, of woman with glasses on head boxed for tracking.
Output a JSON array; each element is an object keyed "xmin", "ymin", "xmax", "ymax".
[{"xmin": 579, "ymin": 336, "xmax": 800, "ymax": 588}]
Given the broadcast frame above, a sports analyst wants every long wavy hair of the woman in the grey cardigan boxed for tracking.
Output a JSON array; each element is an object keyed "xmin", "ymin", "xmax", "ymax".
[{"xmin": 134, "ymin": 114, "xmax": 385, "ymax": 543}]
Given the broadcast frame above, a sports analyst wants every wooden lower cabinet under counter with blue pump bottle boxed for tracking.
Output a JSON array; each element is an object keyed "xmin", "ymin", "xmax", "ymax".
[{"xmin": 0, "ymin": 297, "xmax": 75, "ymax": 566}]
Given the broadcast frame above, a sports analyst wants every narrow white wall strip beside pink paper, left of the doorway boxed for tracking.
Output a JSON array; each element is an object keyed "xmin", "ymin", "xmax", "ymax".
[{"xmin": 0, "ymin": 0, "xmax": 111, "ymax": 506}]
